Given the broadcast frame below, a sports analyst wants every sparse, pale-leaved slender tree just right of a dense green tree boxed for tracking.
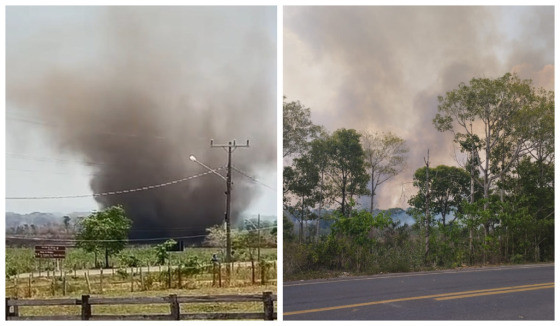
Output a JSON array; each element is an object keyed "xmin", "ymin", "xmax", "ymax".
[{"xmin": 361, "ymin": 131, "xmax": 408, "ymax": 214}]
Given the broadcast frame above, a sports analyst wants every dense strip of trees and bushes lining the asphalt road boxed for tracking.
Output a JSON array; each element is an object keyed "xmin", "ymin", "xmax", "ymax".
[{"xmin": 284, "ymin": 74, "xmax": 554, "ymax": 279}]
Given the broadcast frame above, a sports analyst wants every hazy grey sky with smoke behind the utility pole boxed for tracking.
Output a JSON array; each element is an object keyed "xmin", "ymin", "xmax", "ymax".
[{"xmin": 6, "ymin": 6, "xmax": 277, "ymax": 222}]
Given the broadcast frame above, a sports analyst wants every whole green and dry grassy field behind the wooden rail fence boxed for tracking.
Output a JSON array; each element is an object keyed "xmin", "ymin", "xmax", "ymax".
[{"xmin": 5, "ymin": 246, "xmax": 277, "ymax": 316}]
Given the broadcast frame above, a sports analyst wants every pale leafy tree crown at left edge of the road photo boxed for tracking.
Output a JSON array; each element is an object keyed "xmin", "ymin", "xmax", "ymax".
[{"xmin": 283, "ymin": 97, "xmax": 321, "ymax": 157}]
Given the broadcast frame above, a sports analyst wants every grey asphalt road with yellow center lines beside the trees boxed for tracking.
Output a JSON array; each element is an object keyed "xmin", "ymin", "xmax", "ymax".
[{"xmin": 283, "ymin": 264, "xmax": 554, "ymax": 320}]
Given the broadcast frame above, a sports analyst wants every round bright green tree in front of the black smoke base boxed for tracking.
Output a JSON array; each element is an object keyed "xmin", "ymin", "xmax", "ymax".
[{"xmin": 76, "ymin": 205, "xmax": 132, "ymax": 268}]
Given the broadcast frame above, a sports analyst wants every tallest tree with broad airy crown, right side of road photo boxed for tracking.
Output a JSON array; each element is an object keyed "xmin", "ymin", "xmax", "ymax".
[{"xmin": 433, "ymin": 73, "xmax": 537, "ymax": 228}]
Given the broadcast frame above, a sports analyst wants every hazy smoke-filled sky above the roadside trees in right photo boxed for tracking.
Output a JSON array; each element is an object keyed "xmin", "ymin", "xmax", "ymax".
[{"xmin": 283, "ymin": 6, "xmax": 554, "ymax": 208}]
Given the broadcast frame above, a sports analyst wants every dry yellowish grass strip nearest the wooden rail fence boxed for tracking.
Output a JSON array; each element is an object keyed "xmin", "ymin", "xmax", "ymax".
[{"xmin": 6, "ymin": 268, "xmax": 276, "ymax": 316}]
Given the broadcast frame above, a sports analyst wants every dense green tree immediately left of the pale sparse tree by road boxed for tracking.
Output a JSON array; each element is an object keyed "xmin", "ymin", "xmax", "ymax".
[{"xmin": 326, "ymin": 128, "xmax": 369, "ymax": 216}]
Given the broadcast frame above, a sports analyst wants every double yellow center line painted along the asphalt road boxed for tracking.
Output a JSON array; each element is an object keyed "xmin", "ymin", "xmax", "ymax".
[{"xmin": 284, "ymin": 282, "xmax": 554, "ymax": 316}]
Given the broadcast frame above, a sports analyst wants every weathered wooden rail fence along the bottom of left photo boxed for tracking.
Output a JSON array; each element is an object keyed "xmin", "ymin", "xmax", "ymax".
[{"xmin": 6, "ymin": 292, "xmax": 277, "ymax": 320}]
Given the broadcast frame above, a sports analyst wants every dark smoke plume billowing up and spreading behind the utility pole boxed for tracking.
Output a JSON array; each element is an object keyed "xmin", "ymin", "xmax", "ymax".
[{"xmin": 7, "ymin": 7, "xmax": 276, "ymax": 237}]
